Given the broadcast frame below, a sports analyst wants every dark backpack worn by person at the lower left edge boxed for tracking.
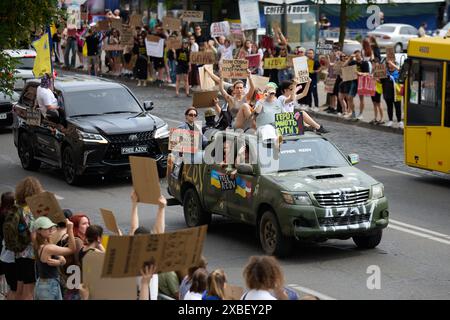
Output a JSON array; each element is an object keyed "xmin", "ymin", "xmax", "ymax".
[{"xmin": 3, "ymin": 209, "xmax": 31, "ymax": 253}]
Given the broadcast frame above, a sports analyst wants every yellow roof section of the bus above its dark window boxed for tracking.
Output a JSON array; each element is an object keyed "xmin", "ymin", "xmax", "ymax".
[{"xmin": 408, "ymin": 37, "xmax": 450, "ymax": 61}]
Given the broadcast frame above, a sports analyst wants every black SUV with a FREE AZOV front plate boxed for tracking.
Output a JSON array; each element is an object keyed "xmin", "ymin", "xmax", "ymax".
[{"xmin": 13, "ymin": 76, "xmax": 169, "ymax": 184}]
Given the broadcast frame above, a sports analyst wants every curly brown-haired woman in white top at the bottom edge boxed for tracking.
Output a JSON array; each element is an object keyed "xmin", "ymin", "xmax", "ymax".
[{"xmin": 241, "ymin": 256, "xmax": 289, "ymax": 300}]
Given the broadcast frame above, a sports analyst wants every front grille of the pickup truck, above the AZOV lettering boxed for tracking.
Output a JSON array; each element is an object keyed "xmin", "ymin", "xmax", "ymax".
[{"xmin": 314, "ymin": 189, "xmax": 369, "ymax": 207}]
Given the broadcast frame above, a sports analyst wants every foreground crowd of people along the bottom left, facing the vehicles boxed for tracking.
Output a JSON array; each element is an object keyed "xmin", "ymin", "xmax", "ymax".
[{"xmin": 0, "ymin": 177, "xmax": 320, "ymax": 300}]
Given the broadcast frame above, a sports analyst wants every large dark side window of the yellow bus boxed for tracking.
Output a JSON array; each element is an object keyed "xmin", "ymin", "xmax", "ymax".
[{"xmin": 407, "ymin": 59, "xmax": 443, "ymax": 125}]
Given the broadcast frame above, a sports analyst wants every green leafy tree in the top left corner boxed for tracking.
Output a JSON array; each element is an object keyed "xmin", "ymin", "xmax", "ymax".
[{"xmin": 0, "ymin": 0, "xmax": 62, "ymax": 95}]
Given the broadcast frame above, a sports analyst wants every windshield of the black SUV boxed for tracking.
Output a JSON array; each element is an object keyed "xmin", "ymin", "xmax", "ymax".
[{"xmin": 64, "ymin": 88, "xmax": 143, "ymax": 117}]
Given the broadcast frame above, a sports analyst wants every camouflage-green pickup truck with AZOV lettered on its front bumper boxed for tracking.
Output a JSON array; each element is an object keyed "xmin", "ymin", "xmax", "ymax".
[{"xmin": 168, "ymin": 131, "xmax": 389, "ymax": 257}]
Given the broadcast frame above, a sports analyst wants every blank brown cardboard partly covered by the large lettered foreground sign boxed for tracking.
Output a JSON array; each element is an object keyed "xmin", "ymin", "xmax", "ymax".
[{"xmin": 83, "ymin": 252, "xmax": 137, "ymax": 300}]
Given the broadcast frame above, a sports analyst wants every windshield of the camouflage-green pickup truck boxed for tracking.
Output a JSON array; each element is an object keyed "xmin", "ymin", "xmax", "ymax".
[{"xmin": 259, "ymin": 138, "xmax": 349, "ymax": 173}]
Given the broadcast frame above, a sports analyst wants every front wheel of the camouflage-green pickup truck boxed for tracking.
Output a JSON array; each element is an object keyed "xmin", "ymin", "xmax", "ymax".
[{"xmin": 259, "ymin": 211, "xmax": 293, "ymax": 258}]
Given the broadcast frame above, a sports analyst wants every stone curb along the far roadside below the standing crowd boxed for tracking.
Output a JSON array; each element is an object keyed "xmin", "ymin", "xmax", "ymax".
[{"xmin": 55, "ymin": 68, "xmax": 403, "ymax": 135}]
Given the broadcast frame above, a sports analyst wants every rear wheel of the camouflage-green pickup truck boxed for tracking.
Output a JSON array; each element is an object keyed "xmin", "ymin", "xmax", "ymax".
[{"xmin": 183, "ymin": 188, "xmax": 211, "ymax": 227}]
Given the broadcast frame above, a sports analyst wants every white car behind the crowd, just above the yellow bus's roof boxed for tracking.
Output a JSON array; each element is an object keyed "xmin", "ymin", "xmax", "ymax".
[{"xmin": 367, "ymin": 23, "xmax": 419, "ymax": 53}]
